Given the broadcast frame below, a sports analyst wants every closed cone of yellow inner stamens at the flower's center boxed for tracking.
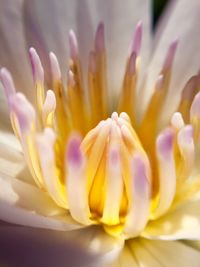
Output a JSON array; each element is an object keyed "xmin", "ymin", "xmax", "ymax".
[{"xmin": 76, "ymin": 112, "xmax": 150, "ymax": 237}]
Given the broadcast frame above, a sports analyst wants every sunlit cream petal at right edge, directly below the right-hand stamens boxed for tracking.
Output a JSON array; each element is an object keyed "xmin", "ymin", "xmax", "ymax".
[{"xmin": 142, "ymin": 198, "xmax": 200, "ymax": 240}]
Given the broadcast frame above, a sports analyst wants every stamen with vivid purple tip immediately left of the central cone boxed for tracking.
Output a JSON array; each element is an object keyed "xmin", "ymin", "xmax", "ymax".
[{"xmin": 65, "ymin": 134, "xmax": 91, "ymax": 225}]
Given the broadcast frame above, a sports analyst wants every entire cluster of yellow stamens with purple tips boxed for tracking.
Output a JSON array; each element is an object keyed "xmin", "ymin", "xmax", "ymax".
[{"xmin": 0, "ymin": 23, "xmax": 200, "ymax": 239}]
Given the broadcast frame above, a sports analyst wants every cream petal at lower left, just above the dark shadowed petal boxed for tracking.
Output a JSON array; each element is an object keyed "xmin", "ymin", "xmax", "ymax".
[{"xmin": 0, "ymin": 173, "xmax": 81, "ymax": 230}]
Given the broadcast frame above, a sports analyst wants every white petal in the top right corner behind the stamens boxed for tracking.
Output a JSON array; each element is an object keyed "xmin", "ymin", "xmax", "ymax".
[{"xmin": 146, "ymin": 0, "xmax": 200, "ymax": 120}]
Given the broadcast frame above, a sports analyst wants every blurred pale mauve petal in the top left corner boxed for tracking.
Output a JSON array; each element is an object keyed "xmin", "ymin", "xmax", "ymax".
[{"xmin": 0, "ymin": 0, "xmax": 32, "ymax": 95}]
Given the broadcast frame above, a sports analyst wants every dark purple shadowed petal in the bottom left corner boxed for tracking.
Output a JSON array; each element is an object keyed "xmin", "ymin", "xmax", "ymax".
[{"xmin": 0, "ymin": 225, "xmax": 101, "ymax": 267}]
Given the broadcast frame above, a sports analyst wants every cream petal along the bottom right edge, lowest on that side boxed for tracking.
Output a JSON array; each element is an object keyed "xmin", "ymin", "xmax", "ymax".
[{"xmin": 105, "ymin": 238, "xmax": 200, "ymax": 267}]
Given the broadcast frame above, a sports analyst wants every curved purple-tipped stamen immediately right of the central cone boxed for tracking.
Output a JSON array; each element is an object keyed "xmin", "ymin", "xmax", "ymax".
[{"xmin": 152, "ymin": 128, "xmax": 176, "ymax": 218}]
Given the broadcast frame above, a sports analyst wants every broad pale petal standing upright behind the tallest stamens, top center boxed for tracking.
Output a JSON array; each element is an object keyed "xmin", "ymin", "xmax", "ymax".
[{"xmin": 25, "ymin": 0, "xmax": 150, "ymax": 94}]
